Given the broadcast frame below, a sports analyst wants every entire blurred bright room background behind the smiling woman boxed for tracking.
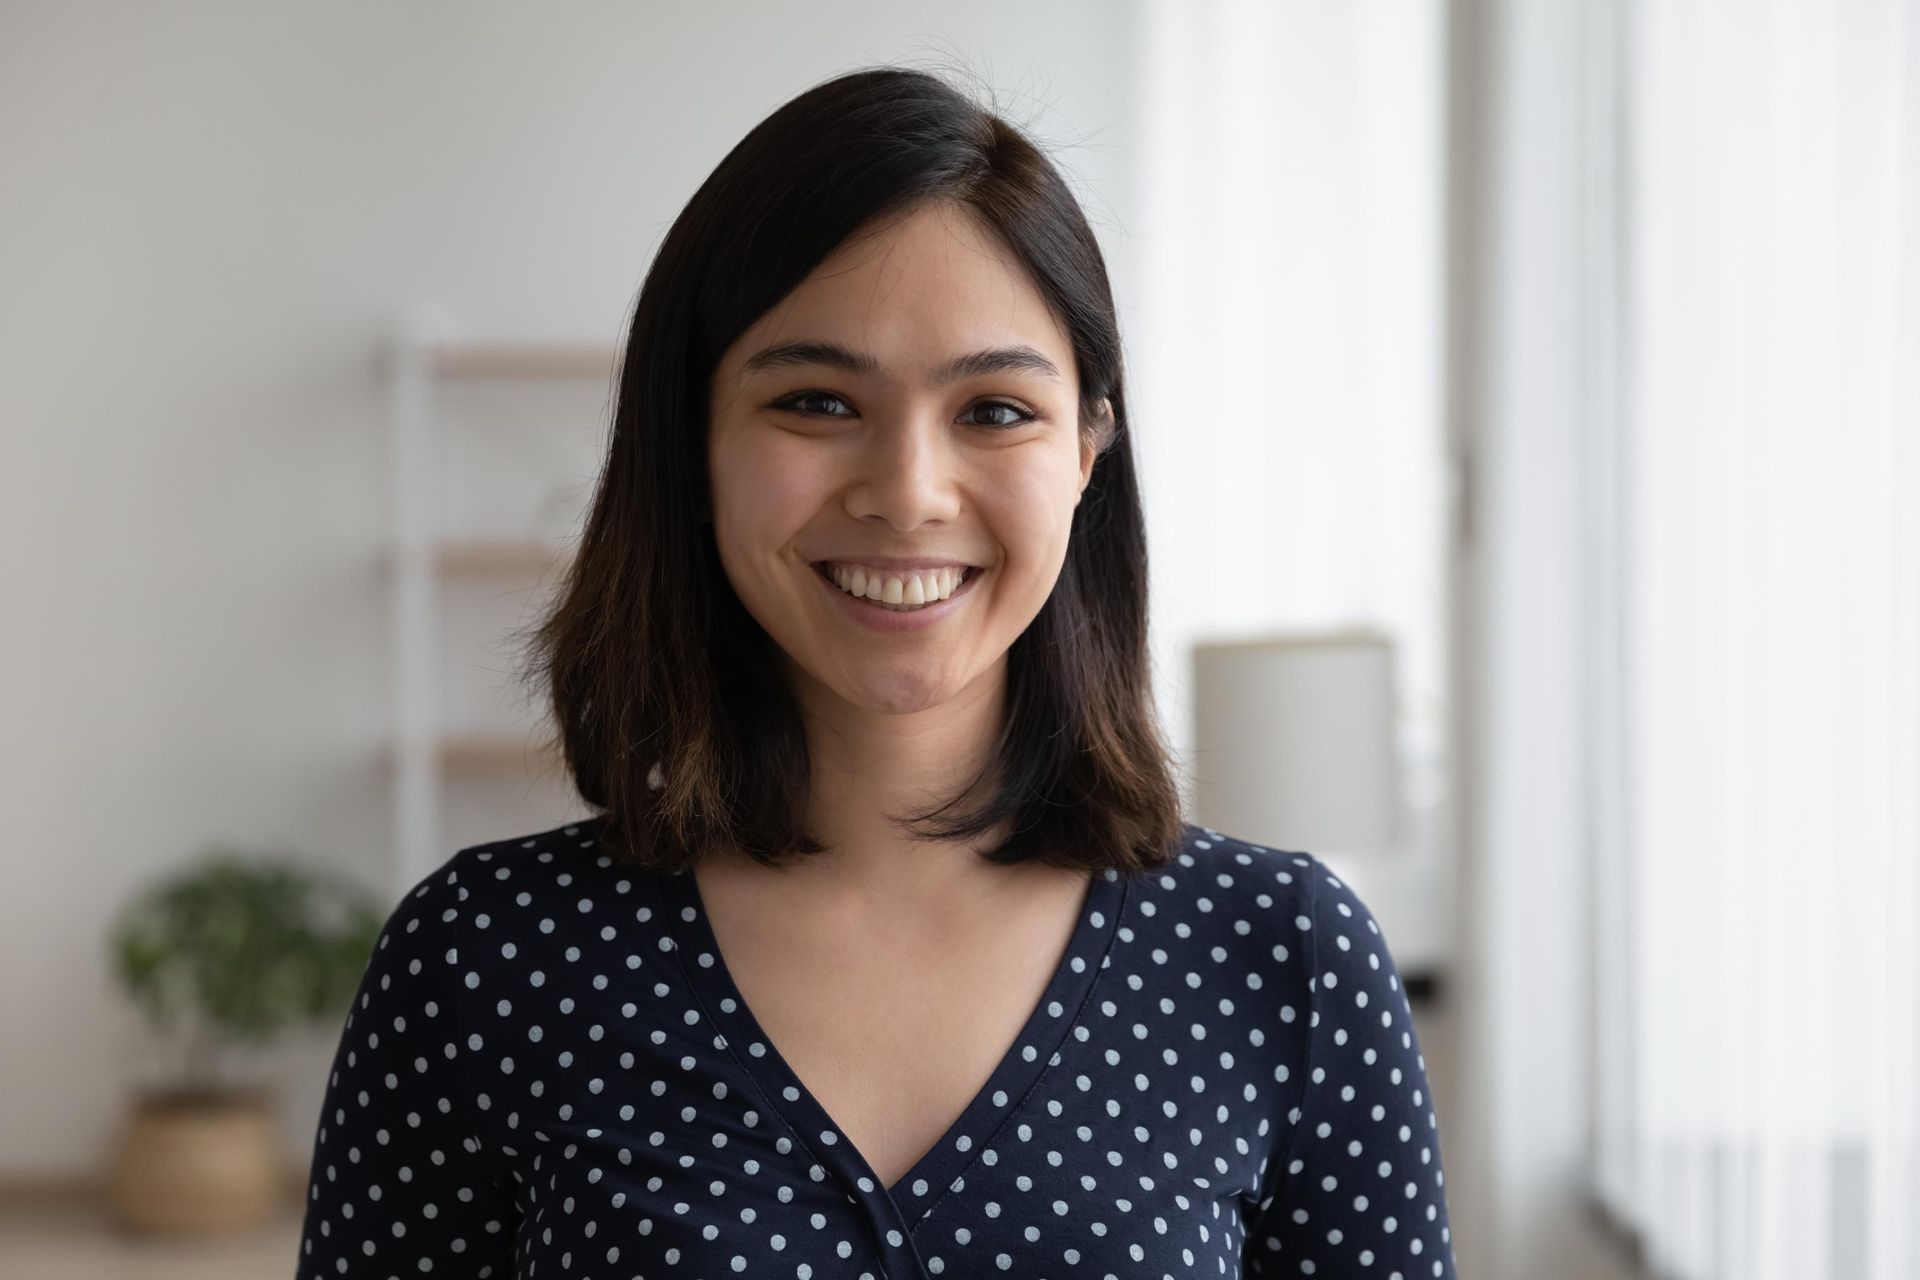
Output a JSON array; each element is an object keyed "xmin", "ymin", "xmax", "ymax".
[{"xmin": 0, "ymin": 0, "xmax": 1920, "ymax": 1280}]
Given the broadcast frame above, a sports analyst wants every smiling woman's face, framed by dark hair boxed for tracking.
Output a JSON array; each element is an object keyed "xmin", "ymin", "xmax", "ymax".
[{"xmin": 708, "ymin": 203, "xmax": 1094, "ymax": 712}]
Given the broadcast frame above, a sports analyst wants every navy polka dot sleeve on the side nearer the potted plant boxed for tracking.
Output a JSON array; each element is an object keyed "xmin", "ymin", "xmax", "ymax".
[{"xmin": 298, "ymin": 854, "xmax": 518, "ymax": 1280}]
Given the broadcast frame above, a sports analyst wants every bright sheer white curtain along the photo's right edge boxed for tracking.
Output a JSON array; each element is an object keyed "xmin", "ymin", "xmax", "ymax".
[{"xmin": 1592, "ymin": 0, "xmax": 1920, "ymax": 1280}]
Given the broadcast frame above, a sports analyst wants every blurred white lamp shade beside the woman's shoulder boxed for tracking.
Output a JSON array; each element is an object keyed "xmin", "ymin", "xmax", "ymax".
[{"xmin": 1190, "ymin": 631, "xmax": 1402, "ymax": 854}]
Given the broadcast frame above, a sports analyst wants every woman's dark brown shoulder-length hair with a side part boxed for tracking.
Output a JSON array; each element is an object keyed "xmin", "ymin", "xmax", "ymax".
[{"xmin": 524, "ymin": 67, "xmax": 1183, "ymax": 873}]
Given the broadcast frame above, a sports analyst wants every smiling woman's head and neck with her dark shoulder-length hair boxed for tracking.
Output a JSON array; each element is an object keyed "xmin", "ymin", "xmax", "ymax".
[{"xmin": 528, "ymin": 67, "xmax": 1181, "ymax": 890}]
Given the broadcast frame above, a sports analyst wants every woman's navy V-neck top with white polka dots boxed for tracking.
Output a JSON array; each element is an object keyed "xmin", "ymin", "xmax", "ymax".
[{"xmin": 298, "ymin": 819, "xmax": 1455, "ymax": 1280}]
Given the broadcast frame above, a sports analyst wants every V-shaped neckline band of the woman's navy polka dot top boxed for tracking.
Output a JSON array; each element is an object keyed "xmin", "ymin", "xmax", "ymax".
[{"xmin": 664, "ymin": 855, "xmax": 1129, "ymax": 1230}]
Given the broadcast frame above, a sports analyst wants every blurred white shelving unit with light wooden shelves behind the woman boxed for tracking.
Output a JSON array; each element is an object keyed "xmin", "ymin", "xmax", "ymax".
[{"xmin": 384, "ymin": 307, "xmax": 618, "ymax": 885}]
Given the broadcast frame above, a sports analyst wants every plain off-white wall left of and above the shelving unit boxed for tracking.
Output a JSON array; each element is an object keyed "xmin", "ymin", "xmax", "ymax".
[{"xmin": 0, "ymin": 0, "xmax": 1137, "ymax": 1174}]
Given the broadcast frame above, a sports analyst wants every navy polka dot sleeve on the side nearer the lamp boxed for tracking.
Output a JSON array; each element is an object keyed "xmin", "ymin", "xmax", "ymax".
[{"xmin": 1244, "ymin": 856, "xmax": 1455, "ymax": 1280}]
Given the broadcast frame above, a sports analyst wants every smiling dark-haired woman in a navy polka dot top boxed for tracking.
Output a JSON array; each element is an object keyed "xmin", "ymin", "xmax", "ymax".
[{"xmin": 300, "ymin": 69, "xmax": 1453, "ymax": 1278}]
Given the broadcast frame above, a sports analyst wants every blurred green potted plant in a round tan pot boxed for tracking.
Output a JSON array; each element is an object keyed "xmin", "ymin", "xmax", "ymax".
[{"xmin": 108, "ymin": 846, "xmax": 384, "ymax": 1232}]
